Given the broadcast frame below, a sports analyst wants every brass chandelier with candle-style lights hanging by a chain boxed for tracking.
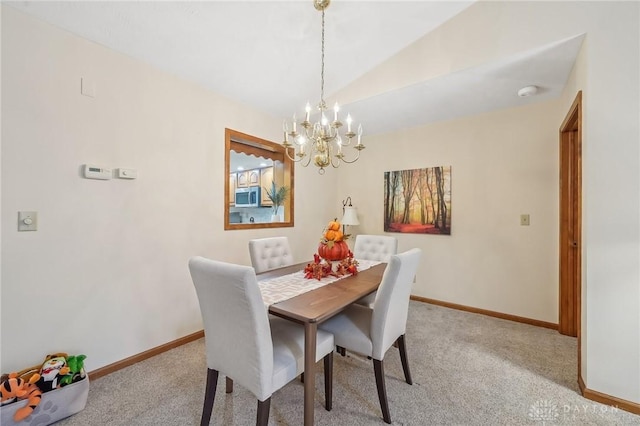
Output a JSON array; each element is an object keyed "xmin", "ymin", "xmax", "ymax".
[{"xmin": 282, "ymin": 0, "xmax": 365, "ymax": 174}]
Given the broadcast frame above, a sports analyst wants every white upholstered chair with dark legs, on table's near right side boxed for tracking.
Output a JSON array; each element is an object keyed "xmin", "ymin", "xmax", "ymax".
[{"xmin": 319, "ymin": 248, "xmax": 422, "ymax": 423}]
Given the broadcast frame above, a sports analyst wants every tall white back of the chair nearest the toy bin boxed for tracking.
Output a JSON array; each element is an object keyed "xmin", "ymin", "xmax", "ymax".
[{"xmin": 189, "ymin": 256, "xmax": 273, "ymax": 401}]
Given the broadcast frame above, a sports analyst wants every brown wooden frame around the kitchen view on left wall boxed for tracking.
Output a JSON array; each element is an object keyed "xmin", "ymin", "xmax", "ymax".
[{"xmin": 224, "ymin": 128, "xmax": 295, "ymax": 230}]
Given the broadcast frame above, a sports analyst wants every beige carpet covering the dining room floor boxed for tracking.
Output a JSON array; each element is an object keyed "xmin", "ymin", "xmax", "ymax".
[{"xmin": 58, "ymin": 302, "xmax": 640, "ymax": 426}]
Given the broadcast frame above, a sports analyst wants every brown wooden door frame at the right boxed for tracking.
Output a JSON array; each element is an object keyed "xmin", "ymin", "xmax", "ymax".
[{"xmin": 558, "ymin": 91, "xmax": 582, "ymax": 364}]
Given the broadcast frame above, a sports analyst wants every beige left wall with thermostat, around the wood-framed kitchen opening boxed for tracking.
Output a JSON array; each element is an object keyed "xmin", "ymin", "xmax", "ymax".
[{"xmin": 1, "ymin": 7, "xmax": 338, "ymax": 372}]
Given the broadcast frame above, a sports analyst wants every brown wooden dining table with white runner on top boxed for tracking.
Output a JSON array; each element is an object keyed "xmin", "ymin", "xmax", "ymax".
[{"xmin": 257, "ymin": 259, "xmax": 387, "ymax": 426}]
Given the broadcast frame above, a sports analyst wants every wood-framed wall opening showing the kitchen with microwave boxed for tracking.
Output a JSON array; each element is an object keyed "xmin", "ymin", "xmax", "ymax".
[{"xmin": 224, "ymin": 129, "xmax": 294, "ymax": 230}]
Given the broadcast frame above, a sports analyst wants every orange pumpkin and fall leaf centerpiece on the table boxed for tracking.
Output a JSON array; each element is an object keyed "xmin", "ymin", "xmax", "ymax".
[{"xmin": 304, "ymin": 219, "xmax": 358, "ymax": 280}]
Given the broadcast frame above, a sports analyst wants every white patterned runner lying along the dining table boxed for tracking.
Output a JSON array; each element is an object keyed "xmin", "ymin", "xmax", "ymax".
[{"xmin": 258, "ymin": 259, "xmax": 381, "ymax": 307}]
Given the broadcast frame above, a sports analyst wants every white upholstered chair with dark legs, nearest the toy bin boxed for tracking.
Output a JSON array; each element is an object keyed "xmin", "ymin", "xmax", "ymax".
[{"xmin": 189, "ymin": 256, "xmax": 334, "ymax": 426}]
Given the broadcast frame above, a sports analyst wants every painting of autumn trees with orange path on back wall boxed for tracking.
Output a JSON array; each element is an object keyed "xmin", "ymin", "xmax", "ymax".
[{"xmin": 384, "ymin": 166, "xmax": 451, "ymax": 235}]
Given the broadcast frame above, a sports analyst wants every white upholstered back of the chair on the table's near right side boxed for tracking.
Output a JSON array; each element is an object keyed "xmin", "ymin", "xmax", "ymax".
[{"xmin": 371, "ymin": 248, "xmax": 422, "ymax": 359}]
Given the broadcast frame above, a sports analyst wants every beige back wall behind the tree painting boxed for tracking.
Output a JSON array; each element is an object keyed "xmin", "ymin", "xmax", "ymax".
[{"xmin": 340, "ymin": 102, "xmax": 561, "ymax": 323}]
